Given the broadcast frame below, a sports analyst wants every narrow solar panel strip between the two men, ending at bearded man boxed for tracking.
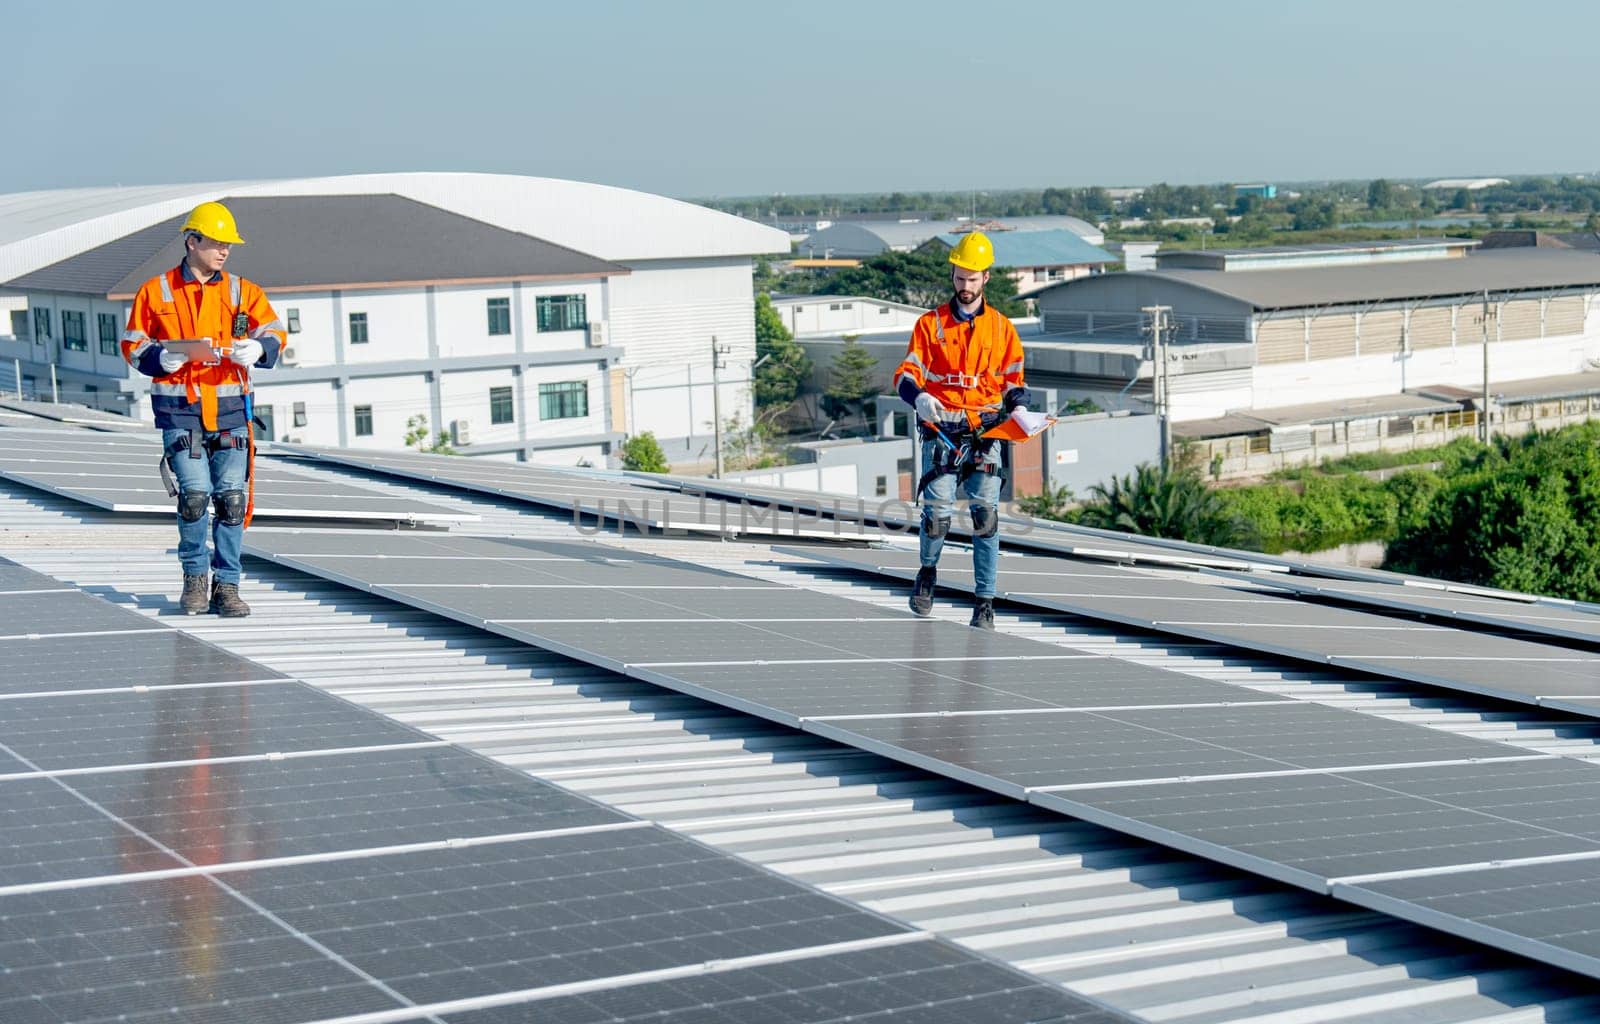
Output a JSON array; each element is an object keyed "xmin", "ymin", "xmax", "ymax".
[{"xmin": 298, "ymin": 448, "xmax": 877, "ymax": 539}]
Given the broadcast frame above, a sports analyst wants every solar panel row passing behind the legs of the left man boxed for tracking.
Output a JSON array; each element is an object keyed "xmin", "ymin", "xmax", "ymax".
[{"xmin": 0, "ymin": 430, "xmax": 478, "ymax": 523}]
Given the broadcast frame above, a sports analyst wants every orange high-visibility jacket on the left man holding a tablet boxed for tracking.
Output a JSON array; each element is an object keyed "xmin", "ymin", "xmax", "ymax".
[{"xmin": 122, "ymin": 264, "xmax": 286, "ymax": 430}]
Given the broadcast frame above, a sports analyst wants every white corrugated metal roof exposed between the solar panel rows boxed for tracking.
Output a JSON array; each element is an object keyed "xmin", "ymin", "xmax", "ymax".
[{"xmin": 9, "ymin": 460, "xmax": 1600, "ymax": 1024}]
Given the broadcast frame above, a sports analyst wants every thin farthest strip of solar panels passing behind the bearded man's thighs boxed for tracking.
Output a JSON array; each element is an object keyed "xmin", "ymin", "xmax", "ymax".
[{"xmin": 646, "ymin": 474, "xmax": 1272, "ymax": 570}]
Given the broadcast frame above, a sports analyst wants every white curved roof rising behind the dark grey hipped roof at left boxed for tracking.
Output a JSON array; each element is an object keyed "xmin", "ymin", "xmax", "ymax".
[{"xmin": 0, "ymin": 171, "xmax": 789, "ymax": 280}]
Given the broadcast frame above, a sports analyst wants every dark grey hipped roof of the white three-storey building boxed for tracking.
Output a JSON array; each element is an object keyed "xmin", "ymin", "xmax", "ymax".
[{"xmin": 8, "ymin": 195, "xmax": 629, "ymax": 298}]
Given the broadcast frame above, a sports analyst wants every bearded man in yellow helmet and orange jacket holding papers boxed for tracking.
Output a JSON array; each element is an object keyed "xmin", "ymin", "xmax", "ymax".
[{"xmin": 894, "ymin": 232, "xmax": 1030, "ymax": 629}]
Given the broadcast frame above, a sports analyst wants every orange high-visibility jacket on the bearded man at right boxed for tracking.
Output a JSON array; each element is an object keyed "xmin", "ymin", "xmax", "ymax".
[{"xmin": 894, "ymin": 302, "xmax": 1022, "ymax": 427}]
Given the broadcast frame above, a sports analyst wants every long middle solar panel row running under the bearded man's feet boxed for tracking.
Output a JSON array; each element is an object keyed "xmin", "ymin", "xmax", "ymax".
[{"xmin": 248, "ymin": 533, "xmax": 1600, "ymax": 976}]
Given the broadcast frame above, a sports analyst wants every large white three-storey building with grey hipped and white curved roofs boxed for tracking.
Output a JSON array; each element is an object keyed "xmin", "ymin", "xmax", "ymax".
[{"xmin": 0, "ymin": 173, "xmax": 789, "ymax": 466}]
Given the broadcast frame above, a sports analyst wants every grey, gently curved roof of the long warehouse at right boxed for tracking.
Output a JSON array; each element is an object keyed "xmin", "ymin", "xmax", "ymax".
[{"xmin": 1048, "ymin": 248, "xmax": 1600, "ymax": 310}]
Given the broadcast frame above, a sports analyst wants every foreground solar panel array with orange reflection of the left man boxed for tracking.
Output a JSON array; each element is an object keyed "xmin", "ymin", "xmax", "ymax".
[{"xmin": 0, "ymin": 560, "xmax": 1126, "ymax": 1024}]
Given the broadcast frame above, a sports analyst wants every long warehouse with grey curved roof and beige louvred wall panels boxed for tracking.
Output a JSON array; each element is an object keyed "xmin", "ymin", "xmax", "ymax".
[{"xmin": 1027, "ymin": 248, "xmax": 1600, "ymax": 435}]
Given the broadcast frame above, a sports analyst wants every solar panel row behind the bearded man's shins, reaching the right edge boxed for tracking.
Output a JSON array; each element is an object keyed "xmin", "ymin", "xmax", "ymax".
[{"xmin": 790, "ymin": 549, "xmax": 1600, "ymax": 715}]
